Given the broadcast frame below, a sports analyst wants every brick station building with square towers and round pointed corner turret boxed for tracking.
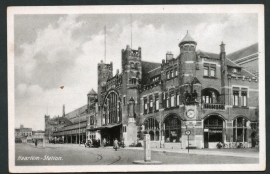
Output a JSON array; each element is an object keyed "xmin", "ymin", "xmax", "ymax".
[{"xmin": 51, "ymin": 33, "xmax": 259, "ymax": 148}]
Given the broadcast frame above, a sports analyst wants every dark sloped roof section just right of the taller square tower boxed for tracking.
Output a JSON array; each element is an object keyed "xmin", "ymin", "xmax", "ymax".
[{"xmin": 142, "ymin": 61, "xmax": 160, "ymax": 84}]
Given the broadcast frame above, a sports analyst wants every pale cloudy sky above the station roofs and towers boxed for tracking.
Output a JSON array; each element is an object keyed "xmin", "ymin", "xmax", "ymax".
[{"xmin": 14, "ymin": 13, "xmax": 258, "ymax": 130}]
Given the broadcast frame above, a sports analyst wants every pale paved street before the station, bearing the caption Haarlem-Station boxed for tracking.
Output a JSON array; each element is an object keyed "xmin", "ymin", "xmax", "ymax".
[{"xmin": 15, "ymin": 144, "xmax": 259, "ymax": 166}]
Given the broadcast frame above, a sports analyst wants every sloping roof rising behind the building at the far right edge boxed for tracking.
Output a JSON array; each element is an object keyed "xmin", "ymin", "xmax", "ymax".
[{"xmin": 227, "ymin": 43, "xmax": 259, "ymax": 61}]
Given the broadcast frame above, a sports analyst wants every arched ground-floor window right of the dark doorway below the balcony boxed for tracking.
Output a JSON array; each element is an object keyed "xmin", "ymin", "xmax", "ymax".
[{"xmin": 233, "ymin": 117, "xmax": 248, "ymax": 142}]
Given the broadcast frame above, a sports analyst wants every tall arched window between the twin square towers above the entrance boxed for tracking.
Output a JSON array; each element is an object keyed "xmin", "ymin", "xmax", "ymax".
[{"xmin": 102, "ymin": 92, "xmax": 121, "ymax": 124}]
